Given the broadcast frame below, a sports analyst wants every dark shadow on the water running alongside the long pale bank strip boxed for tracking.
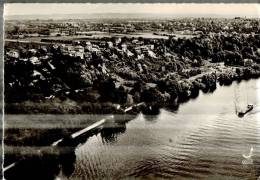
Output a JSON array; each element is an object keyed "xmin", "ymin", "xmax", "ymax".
[{"xmin": 4, "ymin": 115, "xmax": 139, "ymax": 180}]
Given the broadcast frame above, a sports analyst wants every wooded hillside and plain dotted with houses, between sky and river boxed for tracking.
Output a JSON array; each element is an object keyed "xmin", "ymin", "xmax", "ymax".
[{"xmin": 5, "ymin": 18, "xmax": 260, "ymax": 113}]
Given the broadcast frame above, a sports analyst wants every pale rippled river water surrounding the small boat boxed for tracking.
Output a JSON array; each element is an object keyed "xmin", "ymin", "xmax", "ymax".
[{"xmin": 63, "ymin": 79, "xmax": 260, "ymax": 179}]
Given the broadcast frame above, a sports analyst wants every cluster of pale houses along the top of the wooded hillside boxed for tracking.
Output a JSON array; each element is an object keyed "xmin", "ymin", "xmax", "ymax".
[{"xmin": 6, "ymin": 33, "xmax": 160, "ymax": 65}]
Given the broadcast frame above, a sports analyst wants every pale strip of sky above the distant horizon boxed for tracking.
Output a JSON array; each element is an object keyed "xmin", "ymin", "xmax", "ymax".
[{"xmin": 4, "ymin": 3, "xmax": 260, "ymax": 17}]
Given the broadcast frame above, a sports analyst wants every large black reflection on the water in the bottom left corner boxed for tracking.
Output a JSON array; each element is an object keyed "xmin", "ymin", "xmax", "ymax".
[{"xmin": 4, "ymin": 147, "xmax": 76, "ymax": 180}]
